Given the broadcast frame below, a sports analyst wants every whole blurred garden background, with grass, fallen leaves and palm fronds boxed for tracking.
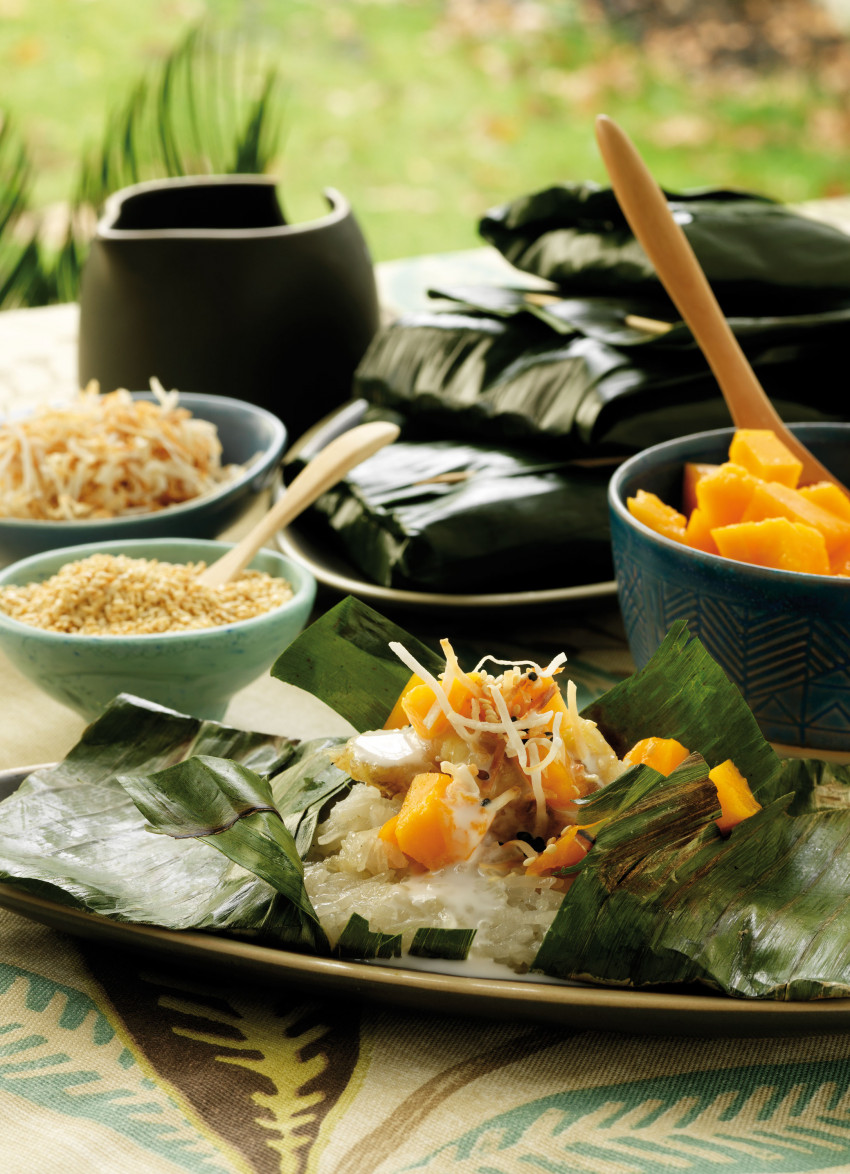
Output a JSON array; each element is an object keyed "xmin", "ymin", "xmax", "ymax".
[{"xmin": 0, "ymin": 0, "xmax": 850, "ymax": 304}]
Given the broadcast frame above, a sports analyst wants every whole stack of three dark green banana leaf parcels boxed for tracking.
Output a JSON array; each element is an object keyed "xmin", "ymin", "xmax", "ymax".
[{"xmin": 302, "ymin": 183, "xmax": 850, "ymax": 593}]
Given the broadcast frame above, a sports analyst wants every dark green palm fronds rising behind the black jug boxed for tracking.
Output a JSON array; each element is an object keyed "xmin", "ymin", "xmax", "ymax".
[{"xmin": 0, "ymin": 26, "xmax": 282, "ymax": 309}]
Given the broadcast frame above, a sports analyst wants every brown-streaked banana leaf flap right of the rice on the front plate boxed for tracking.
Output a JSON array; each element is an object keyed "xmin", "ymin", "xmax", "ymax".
[{"xmin": 532, "ymin": 764, "xmax": 850, "ymax": 1000}]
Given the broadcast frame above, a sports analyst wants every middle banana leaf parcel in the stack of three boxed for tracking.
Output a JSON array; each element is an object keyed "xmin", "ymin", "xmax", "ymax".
[{"xmin": 353, "ymin": 302, "xmax": 850, "ymax": 459}]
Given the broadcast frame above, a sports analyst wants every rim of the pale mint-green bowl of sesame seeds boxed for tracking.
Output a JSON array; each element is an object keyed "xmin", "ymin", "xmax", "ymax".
[{"xmin": 0, "ymin": 538, "xmax": 317, "ymax": 650}]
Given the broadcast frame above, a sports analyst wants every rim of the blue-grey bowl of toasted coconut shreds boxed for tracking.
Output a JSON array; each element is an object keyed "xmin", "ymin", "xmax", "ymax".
[{"xmin": 0, "ymin": 391, "xmax": 289, "ymax": 532}]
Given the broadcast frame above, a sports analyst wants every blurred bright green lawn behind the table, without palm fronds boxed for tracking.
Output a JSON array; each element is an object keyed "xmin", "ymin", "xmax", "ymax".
[{"xmin": 0, "ymin": 0, "xmax": 850, "ymax": 259}]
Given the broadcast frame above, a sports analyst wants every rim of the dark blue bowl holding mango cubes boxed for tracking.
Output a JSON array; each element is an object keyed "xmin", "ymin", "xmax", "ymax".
[{"xmin": 608, "ymin": 420, "xmax": 850, "ymax": 589}]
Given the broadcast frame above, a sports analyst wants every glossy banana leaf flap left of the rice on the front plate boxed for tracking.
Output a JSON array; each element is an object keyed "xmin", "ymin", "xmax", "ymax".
[{"xmin": 0, "ymin": 696, "xmax": 349, "ymax": 950}]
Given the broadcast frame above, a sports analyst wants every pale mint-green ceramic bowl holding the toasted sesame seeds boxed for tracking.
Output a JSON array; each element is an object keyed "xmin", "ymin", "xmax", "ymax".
[{"xmin": 0, "ymin": 539, "xmax": 316, "ymax": 721}]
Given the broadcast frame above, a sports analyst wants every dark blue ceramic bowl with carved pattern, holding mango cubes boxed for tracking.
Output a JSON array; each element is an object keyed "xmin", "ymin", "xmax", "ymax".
[{"xmin": 609, "ymin": 424, "xmax": 850, "ymax": 754}]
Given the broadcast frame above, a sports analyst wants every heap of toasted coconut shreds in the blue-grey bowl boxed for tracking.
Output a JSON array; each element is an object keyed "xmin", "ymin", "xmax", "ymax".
[{"xmin": 0, "ymin": 379, "xmax": 242, "ymax": 521}]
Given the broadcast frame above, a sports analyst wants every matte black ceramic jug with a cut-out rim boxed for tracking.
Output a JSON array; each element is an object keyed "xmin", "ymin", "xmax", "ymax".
[{"xmin": 79, "ymin": 175, "xmax": 378, "ymax": 438}]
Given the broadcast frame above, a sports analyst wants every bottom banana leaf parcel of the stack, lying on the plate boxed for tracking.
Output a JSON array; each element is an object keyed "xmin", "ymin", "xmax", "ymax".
[{"xmin": 290, "ymin": 439, "xmax": 614, "ymax": 593}]
